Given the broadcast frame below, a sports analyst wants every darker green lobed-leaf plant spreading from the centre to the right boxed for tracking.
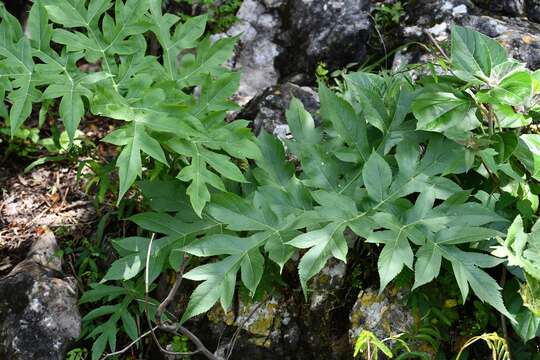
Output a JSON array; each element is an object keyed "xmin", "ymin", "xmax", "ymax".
[{"xmin": 88, "ymin": 27, "xmax": 535, "ymax": 354}]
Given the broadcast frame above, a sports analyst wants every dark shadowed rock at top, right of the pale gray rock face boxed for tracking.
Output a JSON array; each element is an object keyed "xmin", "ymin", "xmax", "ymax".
[{"xmin": 278, "ymin": 0, "xmax": 372, "ymax": 80}]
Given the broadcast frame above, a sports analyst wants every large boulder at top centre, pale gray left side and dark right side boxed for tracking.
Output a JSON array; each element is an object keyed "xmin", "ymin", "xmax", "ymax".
[{"xmin": 215, "ymin": 0, "xmax": 371, "ymax": 105}]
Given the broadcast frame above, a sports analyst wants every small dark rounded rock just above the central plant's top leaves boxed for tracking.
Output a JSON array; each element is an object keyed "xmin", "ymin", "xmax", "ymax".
[{"xmin": 238, "ymin": 83, "xmax": 319, "ymax": 139}]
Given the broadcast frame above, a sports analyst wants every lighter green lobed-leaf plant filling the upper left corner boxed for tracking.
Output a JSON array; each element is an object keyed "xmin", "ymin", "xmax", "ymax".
[{"xmin": 0, "ymin": 0, "xmax": 251, "ymax": 359}]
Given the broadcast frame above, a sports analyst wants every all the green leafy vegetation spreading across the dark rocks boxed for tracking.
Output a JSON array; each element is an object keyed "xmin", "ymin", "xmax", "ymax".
[{"xmin": 0, "ymin": 0, "xmax": 540, "ymax": 359}]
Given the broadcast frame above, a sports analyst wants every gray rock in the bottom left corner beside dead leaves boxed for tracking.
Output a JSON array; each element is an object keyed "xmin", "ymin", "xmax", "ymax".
[{"xmin": 0, "ymin": 231, "xmax": 81, "ymax": 360}]
